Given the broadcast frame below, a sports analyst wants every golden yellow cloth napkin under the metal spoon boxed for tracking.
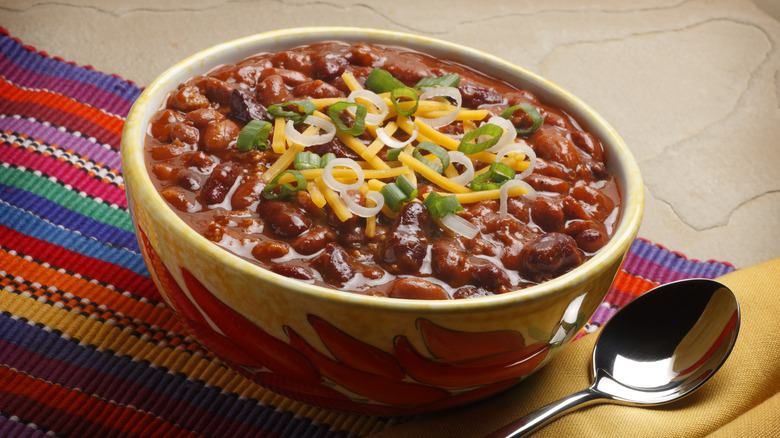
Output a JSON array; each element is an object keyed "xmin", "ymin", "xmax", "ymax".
[{"xmin": 371, "ymin": 258, "xmax": 780, "ymax": 438}]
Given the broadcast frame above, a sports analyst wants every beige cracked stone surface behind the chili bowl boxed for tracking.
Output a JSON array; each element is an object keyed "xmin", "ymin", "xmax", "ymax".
[{"xmin": 0, "ymin": 0, "xmax": 780, "ymax": 267}]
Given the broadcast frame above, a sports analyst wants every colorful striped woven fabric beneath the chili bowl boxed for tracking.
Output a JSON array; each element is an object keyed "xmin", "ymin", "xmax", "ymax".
[{"xmin": 0, "ymin": 28, "xmax": 734, "ymax": 438}]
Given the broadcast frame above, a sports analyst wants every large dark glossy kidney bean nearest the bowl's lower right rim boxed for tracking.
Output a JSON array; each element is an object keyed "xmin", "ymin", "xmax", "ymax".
[{"xmin": 523, "ymin": 233, "xmax": 582, "ymax": 281}]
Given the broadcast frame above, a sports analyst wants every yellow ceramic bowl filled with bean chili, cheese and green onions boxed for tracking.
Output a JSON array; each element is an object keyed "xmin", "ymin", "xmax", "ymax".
[{"xmin": 122, "ymin": 28, "xmax": 643, "ymax": 416}]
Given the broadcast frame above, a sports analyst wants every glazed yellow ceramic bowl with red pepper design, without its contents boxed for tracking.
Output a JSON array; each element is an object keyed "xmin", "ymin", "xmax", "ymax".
[{"xmin": 122, "ymin": 28, "xmax": 643, "ymax": 415}]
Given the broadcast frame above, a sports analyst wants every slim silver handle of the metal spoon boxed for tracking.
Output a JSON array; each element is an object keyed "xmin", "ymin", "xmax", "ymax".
[{"xmin": 485, "ymin": 388, "xmax": 604, "ymax": 438}]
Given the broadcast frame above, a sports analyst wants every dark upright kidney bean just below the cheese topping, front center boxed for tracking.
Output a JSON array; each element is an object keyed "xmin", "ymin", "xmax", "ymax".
[{"xmin": 382, "ymin": 202, "xmax": 430, "ymax": 273}]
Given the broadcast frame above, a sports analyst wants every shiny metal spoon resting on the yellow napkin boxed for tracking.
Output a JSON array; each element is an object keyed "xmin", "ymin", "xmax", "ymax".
[{"xmin": 487, "ymin": 279, "xmax": 740, "ymax": 438}]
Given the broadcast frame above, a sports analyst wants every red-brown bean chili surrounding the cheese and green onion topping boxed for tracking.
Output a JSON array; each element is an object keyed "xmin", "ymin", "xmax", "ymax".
[{"xmin": 146, "ymin": 42, "xmax": 620, "ymax": 299}]
